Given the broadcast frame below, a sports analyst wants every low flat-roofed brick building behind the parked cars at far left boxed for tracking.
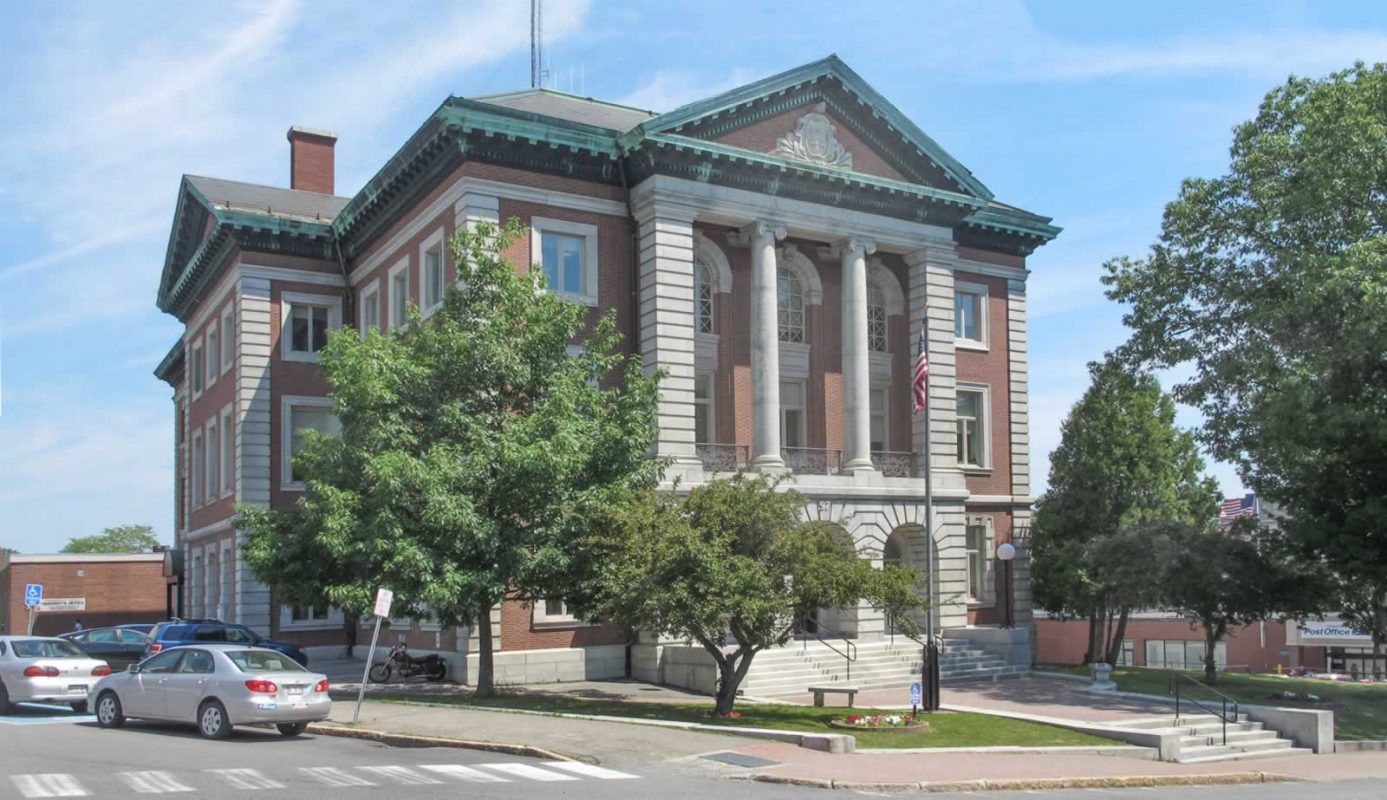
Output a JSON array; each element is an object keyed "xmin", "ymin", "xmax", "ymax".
[{"xmin": 0, "ymin": 553, "xmax": 176, "ymax": 636}]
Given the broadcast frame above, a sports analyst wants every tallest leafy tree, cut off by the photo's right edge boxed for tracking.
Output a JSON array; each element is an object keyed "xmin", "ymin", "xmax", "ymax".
[{"xmin": 1104, "ymin": 64, "xmax": 1387, "ymax": 650}]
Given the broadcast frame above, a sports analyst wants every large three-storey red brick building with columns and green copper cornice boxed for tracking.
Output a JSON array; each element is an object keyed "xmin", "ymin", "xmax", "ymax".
[{"xmin": 157, "ymin": 57, "xmax": 1058, "ymax": 684}]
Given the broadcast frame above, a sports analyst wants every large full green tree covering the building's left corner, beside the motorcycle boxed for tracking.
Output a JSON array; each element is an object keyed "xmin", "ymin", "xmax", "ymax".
[{"xmin": 239, "ymin": 219, "xmax": 662, "ymax": 696}]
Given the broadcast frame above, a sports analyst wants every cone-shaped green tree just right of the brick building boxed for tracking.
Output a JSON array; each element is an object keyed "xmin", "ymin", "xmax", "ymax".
[{"xmin": 1031, "ymin": 359, "xmax": 1218, "ymax": 664}]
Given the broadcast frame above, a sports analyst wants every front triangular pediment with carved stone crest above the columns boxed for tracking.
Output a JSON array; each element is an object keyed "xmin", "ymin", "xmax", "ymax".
[{"xmin": 641, "ymin": 55, "xmax": 992, "ymax": 201}]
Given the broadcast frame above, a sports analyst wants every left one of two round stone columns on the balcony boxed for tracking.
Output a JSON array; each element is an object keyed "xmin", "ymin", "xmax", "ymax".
[{"xmin": 736, "ymin": 222, "xmax": 785, "ymax": 470}]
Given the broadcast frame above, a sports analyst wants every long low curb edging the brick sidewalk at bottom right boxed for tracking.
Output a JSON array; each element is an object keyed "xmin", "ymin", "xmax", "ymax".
[{"xmin": 750, "ymin": 772, "xmax": 1300, "ymax": 793}]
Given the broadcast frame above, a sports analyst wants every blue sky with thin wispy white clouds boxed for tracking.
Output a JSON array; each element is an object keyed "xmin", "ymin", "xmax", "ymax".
[{"xmin": 0, "ymin": 0, "xmax": 1387, "ymax": 552}]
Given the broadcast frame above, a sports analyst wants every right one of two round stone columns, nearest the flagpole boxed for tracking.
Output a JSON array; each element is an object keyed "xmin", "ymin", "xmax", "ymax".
[{"xmin": 834, "ymin": 238, "xmax": 877, "ymax": 473}]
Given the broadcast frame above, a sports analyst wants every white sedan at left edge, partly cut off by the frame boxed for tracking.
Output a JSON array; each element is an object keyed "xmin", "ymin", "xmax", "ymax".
[{"xmin": 0, "ymin": 636, "xmax": 111, "ymax": 714}]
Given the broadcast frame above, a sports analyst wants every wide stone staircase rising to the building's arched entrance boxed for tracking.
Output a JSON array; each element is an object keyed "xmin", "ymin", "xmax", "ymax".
[{"xmin": 741, "ymin": 636, "xmax": 1028, "ymax": 697}]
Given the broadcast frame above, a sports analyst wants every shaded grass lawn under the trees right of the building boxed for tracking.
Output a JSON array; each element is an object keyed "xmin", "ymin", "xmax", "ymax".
[{"xmin": 1043, "ymin": 667, "xmax": 1387, "ymax": 739}]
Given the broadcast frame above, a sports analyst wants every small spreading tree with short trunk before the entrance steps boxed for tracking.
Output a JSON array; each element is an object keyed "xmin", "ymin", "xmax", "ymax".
[{"xmin": 584, "ymin": 476, "xmax": 922, "ymax": 715}]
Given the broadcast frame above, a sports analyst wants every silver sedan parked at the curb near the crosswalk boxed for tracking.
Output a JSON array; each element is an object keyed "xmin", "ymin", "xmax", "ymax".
[{"xmin": 89, "ymin": 642, "xmax": 333, "ymax": 739}]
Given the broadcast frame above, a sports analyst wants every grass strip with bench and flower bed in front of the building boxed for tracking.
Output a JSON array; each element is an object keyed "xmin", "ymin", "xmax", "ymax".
[{"xmin": 372, "ymin": 695, "xmax": 1114, "ymax": 747}]
